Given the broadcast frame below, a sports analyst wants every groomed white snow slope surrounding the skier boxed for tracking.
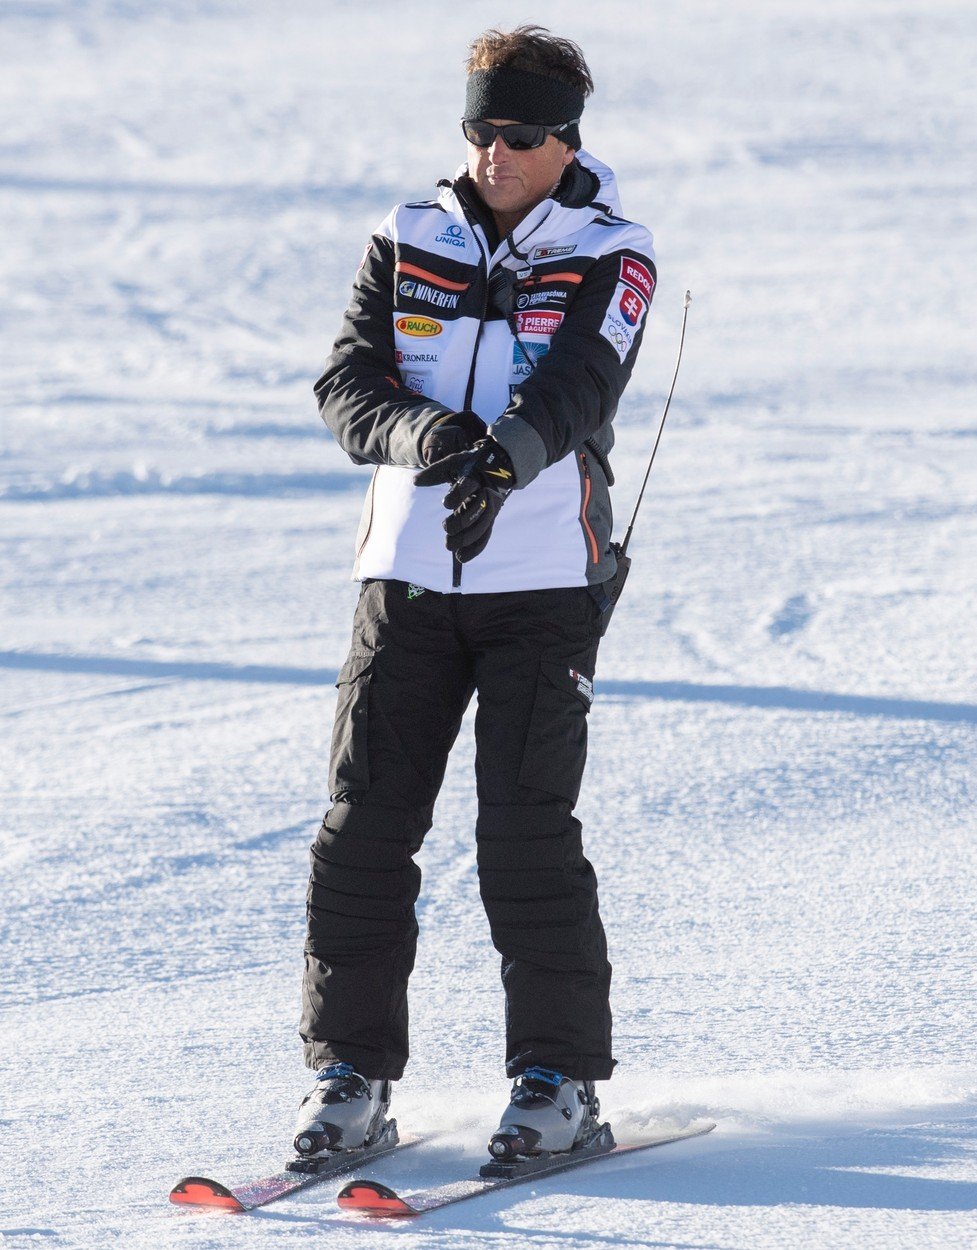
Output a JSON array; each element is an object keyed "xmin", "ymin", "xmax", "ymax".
[{"xmin": 0, "ymin": 0, "xmax": 977, "ymax": 1250}]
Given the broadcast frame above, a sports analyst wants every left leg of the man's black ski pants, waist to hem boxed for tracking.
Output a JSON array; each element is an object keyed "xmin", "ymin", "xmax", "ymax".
[{"xmin": 300, "ymin": 581, "xmax": 472, "ymax": 1080}]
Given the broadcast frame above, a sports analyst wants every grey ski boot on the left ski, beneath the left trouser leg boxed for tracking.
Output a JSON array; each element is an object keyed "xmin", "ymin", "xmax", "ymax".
[{"xmin": 294, "ymin": 1064, "xmax": 397, "ymax": 1159}]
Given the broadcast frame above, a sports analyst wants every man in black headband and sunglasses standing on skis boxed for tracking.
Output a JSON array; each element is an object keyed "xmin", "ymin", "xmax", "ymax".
[{"xmin": 296, "ymin": 26, "xmax": 655, "ymax": 1155}]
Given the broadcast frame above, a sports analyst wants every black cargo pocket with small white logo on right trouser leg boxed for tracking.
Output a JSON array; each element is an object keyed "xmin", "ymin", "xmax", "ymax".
[{"xmin": 518, "ymin": 660, "xmax": 593, "ymax": 804}]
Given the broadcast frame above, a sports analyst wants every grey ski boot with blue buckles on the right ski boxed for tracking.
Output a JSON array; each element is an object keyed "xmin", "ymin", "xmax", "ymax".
[{"xmin": 489, "ymin": 1068, "xmax": 610, "ymax": 1164}]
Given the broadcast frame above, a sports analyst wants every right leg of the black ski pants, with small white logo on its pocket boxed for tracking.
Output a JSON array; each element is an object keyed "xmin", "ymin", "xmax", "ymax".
[{"xmin": 465, "ymin": 588, "xmax": 615, "ymax": 1080}]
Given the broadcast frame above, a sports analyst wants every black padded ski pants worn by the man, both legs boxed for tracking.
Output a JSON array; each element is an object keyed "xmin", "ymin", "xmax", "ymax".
[{"xmin": 300, "ymin": 581, "xmax": 615, "ymax": 1080}]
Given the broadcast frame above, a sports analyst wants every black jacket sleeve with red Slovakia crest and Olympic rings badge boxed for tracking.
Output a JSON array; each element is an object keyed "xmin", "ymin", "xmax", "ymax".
[{"xmin": 489, "ymin": 236, "xmax": 656, "ymax": 486}]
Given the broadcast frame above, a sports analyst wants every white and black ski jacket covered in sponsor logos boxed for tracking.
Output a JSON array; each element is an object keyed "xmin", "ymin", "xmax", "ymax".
[{"xmin": 315, "ymin": 151, "xmax": 656, "ymax": 594}]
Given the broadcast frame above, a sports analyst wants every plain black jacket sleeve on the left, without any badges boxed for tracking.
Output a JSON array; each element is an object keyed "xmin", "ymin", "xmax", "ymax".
[{"xmin": 315, "ymin": 226, "xmax": 450, "ymax": 466}]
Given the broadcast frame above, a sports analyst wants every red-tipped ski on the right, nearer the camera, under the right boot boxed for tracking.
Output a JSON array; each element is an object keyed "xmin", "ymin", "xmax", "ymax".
[{"xmin": 336, "ymin": 1120, "xmax": 716, "ymax": 1219}]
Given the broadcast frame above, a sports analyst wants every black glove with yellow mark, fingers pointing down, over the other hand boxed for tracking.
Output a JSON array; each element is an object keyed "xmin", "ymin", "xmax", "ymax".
[{"xmin": 414, "ymin": 439, "xmax": 515, "ymax": 564}]
